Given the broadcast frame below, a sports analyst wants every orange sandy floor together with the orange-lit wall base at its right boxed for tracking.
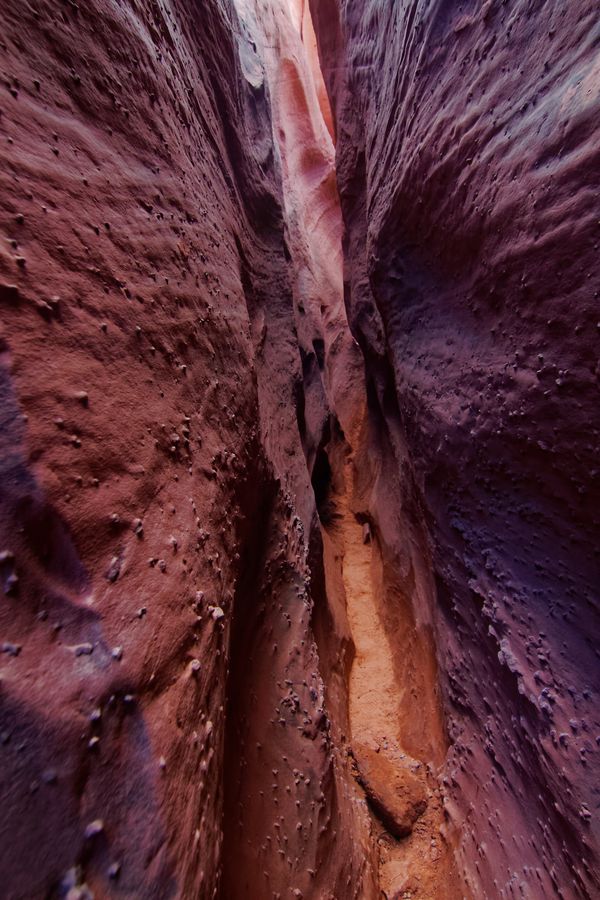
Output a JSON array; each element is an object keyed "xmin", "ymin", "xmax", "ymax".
[{"xmin": 319, "ymin": 412, "xmax": 461, "ymax": 900}]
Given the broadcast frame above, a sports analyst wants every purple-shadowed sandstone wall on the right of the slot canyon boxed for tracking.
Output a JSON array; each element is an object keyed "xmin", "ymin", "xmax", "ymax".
[{"xmin": 311, "ymin": 0, "xmax": 600, "ymax": 898}]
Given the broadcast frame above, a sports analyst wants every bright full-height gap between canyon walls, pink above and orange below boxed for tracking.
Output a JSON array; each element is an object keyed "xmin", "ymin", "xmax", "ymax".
[{"xmin": 232, "ymin": 0, "xmax": 460, "ymax": 900}]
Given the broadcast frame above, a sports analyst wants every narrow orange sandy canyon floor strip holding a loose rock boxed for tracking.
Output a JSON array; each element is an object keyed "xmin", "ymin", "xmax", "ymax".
[{"xmin": 323, "ymin": 412, "xmax": 461, "ymax": 900}]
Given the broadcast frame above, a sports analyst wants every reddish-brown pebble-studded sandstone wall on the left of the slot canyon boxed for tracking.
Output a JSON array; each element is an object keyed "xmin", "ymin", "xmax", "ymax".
[{"xmin": 0, "ymin": 0, "xmax": 368, "ymax": 900}]
